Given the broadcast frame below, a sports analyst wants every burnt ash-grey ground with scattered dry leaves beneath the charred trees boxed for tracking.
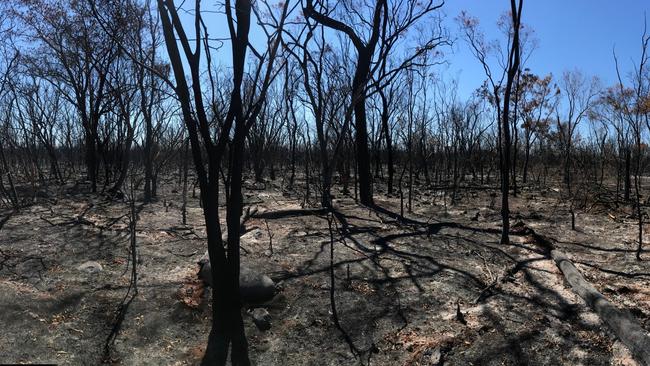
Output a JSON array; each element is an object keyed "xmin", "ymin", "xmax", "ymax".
[{"xmin": 0, "ymin": 179, "xmax": 650, "ymax": 365}]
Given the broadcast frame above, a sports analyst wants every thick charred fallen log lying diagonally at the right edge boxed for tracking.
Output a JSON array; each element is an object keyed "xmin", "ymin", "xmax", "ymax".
[{"xmin": 551, "ymin": 249, "xmax": 650, "ymax": 365}]
